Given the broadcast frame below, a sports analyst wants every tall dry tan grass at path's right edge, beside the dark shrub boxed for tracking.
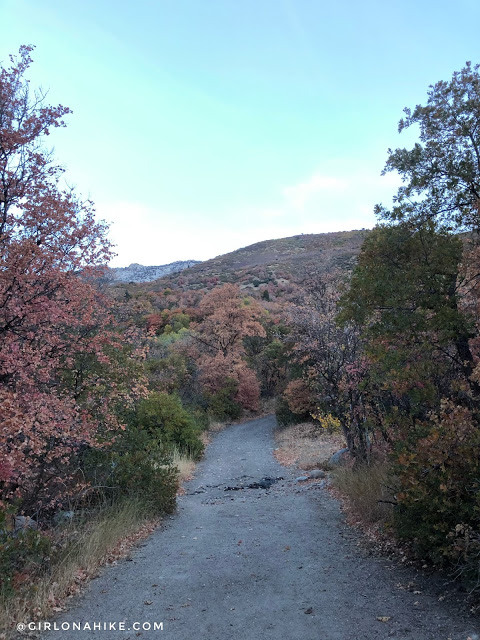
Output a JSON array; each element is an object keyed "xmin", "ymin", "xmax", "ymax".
[{"xmin": 332, "ymin": 463, "xmax": 393, "ymax": 526}]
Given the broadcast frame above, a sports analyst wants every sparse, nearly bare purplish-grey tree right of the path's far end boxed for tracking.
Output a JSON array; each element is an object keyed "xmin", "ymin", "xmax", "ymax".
[{"xmin": 286, "ymin": 270, "xmax": 368, "ymax": 458}]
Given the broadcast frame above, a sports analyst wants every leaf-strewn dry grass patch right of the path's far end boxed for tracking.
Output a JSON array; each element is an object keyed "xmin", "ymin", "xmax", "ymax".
[{"xmin": 274, "ymin": 422, "xmax": 345, "ymax": 471}]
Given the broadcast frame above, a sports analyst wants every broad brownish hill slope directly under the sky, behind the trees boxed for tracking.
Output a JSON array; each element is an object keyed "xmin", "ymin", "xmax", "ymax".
[{"xmin": 141, "ymin": 229, "xmax": 368, "ymax": 291}]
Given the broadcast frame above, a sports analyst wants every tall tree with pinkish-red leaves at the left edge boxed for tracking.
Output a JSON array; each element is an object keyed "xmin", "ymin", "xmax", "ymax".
[{"xmin": 0, "ymin": 46, "xmax": 138, "ymax": 509}]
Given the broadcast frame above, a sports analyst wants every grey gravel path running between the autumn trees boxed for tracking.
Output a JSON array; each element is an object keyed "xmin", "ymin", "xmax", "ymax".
[{"xmin": 43, "ymin": 417, "xmax": 476, "ymax": 640}]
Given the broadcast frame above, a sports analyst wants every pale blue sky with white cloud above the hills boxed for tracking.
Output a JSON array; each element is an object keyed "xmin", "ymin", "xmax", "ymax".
[{"xmin": 0, "ymin": 0, "xmax": 480, "ymax": 266}]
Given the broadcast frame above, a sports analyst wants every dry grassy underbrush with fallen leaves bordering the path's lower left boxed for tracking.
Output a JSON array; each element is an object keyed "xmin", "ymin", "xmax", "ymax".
[{"xmin": 0, "ymin": 499, "xmax": 158, "ymax": 638}]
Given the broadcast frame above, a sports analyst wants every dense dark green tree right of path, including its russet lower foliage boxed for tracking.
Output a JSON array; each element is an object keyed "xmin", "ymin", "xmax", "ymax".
[{"xmin": 339, "ymin": 221, "xmax": 479, "ymax": 428}]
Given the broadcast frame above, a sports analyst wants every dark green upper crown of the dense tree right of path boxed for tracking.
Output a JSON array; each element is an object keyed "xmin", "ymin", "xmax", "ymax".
[{"xmin": 340, "ymin": 221, "xmax": 476, "ymax": 389}]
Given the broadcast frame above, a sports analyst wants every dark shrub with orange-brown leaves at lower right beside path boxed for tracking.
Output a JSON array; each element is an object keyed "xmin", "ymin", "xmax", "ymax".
[{"xmin": 394, "ymin": 401, "xmax": 480, "ymax": 573}]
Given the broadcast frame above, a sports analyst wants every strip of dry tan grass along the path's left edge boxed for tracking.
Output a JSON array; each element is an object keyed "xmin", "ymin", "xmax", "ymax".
[{"xmin": 0, "ymin": 501, "xmax": 159, "ymax": 638}]
